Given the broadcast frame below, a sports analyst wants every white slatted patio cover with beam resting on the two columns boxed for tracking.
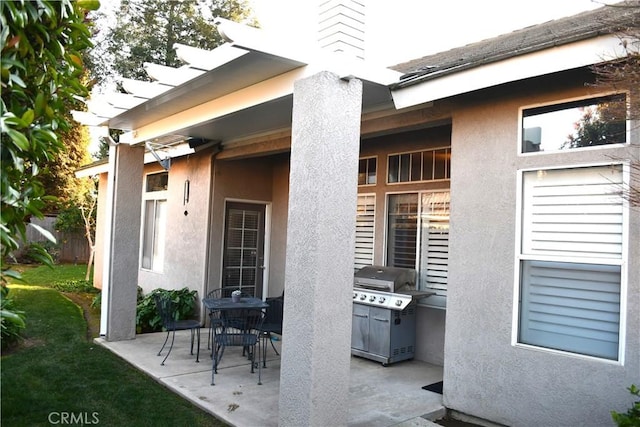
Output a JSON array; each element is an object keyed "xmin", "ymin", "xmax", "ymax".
[{"xmin": 76, "ymin": 18, "xmax": 402, "ymax": 148}]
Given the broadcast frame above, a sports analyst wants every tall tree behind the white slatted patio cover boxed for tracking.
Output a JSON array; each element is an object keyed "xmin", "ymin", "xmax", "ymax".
[{"xmin": 93, "ymin": 0, "xmax": 255, "ymax": 81}]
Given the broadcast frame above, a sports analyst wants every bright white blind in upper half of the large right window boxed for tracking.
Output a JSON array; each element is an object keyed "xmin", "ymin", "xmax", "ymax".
[{"xmin": 522, "ymin": 167, "xmax": 622, "ymax": 259}]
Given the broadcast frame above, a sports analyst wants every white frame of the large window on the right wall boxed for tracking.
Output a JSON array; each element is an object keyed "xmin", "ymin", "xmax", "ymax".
[{"xmin": 511, "ymin": 162, "xmax": 631, "ymax": 366}]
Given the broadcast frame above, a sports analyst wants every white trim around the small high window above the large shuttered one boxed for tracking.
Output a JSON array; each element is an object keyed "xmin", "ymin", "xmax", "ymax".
[{"xmin": 516, "ymin": 90, "xmax": 631, "ymax": 158}]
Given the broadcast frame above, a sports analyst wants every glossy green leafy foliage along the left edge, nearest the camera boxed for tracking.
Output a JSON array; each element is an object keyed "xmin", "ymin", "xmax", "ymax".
[{"xmin": 0, "ymin": 0, "xmax": 100, "ymax": 285}]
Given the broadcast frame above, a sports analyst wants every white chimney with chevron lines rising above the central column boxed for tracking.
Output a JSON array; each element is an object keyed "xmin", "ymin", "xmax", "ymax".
[{"xmin": 318, "ymin": 0, "xmax": 366, "ymax": 59}]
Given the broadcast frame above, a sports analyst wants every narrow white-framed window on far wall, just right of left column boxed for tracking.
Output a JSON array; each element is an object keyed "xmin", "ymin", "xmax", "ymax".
[{"xmin": 140, "ymin": 172, "xmax": 169, "ymax": 271}]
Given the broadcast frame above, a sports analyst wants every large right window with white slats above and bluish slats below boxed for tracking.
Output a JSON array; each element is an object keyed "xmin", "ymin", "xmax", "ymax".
[{"xmin": 518, "ymin": 165, "xmax": 624, "ymax": 360}]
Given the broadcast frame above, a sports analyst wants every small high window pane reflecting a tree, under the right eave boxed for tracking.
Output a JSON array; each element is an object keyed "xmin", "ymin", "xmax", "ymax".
[{"xmin": 522, "ymin": 94, "xmax": 627, "ymax": 153}]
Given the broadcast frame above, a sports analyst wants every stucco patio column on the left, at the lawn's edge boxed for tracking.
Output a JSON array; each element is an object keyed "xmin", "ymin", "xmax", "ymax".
[{"xmin": 103, "ymin": 144, "xmax": 144, "ymax": 341}]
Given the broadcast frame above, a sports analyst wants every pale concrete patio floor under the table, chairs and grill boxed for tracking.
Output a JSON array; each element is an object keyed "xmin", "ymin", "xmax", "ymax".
[{"xmin": 96, "ymin": 329, "xmax": 445, "ymax": 427}]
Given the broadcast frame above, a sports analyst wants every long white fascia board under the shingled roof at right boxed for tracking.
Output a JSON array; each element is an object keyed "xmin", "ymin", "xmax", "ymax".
[{"xmin": 391, "ymin": 36, "xmax": 624, "ymax": 109}]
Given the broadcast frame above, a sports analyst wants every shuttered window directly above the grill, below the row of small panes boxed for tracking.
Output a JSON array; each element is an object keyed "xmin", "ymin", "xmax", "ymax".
[{"xmin": 387, "ymin": 191, "xmax": 450, "ymax": 305}]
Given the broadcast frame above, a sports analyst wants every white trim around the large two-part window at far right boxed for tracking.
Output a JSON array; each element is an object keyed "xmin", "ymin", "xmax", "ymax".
[{"xmin": 511, "ymin": 161, "xmax": 631, "ymax": 366}]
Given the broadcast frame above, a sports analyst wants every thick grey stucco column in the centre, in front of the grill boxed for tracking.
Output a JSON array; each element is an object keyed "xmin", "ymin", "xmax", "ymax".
[{"xmin": 279, "ymin": 72, "xmax": 362, "ymax": 426}]
